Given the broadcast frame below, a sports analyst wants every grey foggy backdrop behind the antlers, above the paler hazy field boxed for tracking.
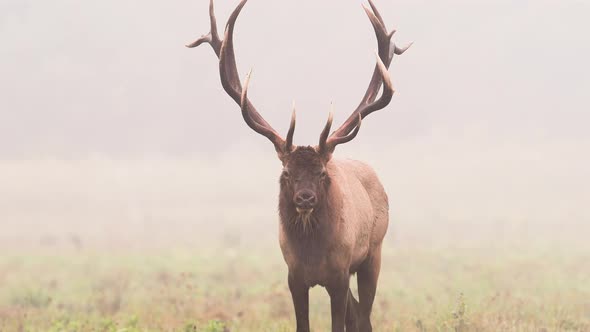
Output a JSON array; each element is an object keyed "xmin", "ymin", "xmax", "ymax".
[{"xmin": 0, "ymin": 0, "xmax": 590, "ymax": 159}]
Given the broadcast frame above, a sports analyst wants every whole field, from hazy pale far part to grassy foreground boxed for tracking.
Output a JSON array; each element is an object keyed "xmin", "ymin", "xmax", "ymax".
[{"xmin": 0, "ymin": 158, "xmax": 590, "ymax": 332}]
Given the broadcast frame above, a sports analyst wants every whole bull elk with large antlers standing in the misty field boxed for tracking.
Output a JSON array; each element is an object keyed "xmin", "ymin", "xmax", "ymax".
[{"xmin": 187, "ymin": 0, "xmax": 411, "ymax": 332}]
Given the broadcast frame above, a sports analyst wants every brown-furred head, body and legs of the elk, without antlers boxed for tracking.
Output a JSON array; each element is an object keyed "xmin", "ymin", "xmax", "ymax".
[{"xmin": 279, "ymin": 147, "xmax": 388, "ymax": 331}]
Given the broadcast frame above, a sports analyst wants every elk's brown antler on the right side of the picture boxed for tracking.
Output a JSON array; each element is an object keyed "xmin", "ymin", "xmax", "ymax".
[{"xmin": 319, "ymin": 0, "xmax": 412, "ymax": 153}]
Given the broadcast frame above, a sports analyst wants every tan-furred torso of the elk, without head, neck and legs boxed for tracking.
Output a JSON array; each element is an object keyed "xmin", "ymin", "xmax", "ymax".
[{"xmin": 279, "ymin": 160, "xmax": 389, "ymax": 287}]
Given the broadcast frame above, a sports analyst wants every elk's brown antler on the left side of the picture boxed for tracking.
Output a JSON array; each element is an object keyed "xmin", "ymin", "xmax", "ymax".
[{"xmin": 186, "ymin": 0, "xmax": 295, "ymax": 156}]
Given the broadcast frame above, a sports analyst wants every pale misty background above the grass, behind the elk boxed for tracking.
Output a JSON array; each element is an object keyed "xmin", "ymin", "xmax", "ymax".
[{"xmin": 0, "ymin": 0, "xmax": 590, "ymax": 247}]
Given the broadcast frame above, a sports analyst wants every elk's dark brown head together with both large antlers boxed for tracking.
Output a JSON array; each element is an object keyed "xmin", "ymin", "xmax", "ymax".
[{"xmin": 186, "ymin": 0, "xmax": 411, "ymax": 226}]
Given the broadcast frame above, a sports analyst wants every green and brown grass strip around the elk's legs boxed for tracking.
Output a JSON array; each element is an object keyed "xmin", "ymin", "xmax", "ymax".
[{"xmin": 0, "ymin": 245, "xmax": 590, "ymax": 332}]
